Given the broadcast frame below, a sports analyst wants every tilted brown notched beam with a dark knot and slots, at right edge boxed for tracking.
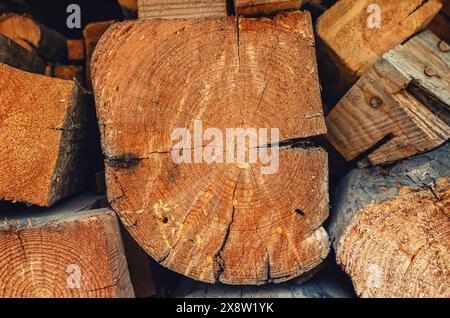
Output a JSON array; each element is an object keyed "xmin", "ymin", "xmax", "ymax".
[{"xmin": 327, "ymin": 31, "xmax": 450, "ymax": 166}]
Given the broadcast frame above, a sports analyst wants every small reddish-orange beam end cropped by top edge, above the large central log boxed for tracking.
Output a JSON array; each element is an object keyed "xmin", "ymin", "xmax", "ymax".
[{"xmin": 234, "ymin": 0, "xmax": 303, "ymax": 16}]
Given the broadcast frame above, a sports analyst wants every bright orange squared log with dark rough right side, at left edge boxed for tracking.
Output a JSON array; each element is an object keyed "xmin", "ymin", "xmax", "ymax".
[{"xmin": 0, "ymin": 64, "xmax": 87, "ymax": 206}]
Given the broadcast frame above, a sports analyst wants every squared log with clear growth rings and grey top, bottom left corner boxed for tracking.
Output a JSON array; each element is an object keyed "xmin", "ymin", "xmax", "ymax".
[{"xmin": 0, "ymin": 195, "xmax": 134, "ymax": 298}]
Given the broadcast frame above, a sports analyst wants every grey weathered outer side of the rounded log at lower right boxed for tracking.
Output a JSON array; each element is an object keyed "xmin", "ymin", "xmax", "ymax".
[{"xmin": 328, "ymin": 143, "xmax": 450, "ymax": 249}]
